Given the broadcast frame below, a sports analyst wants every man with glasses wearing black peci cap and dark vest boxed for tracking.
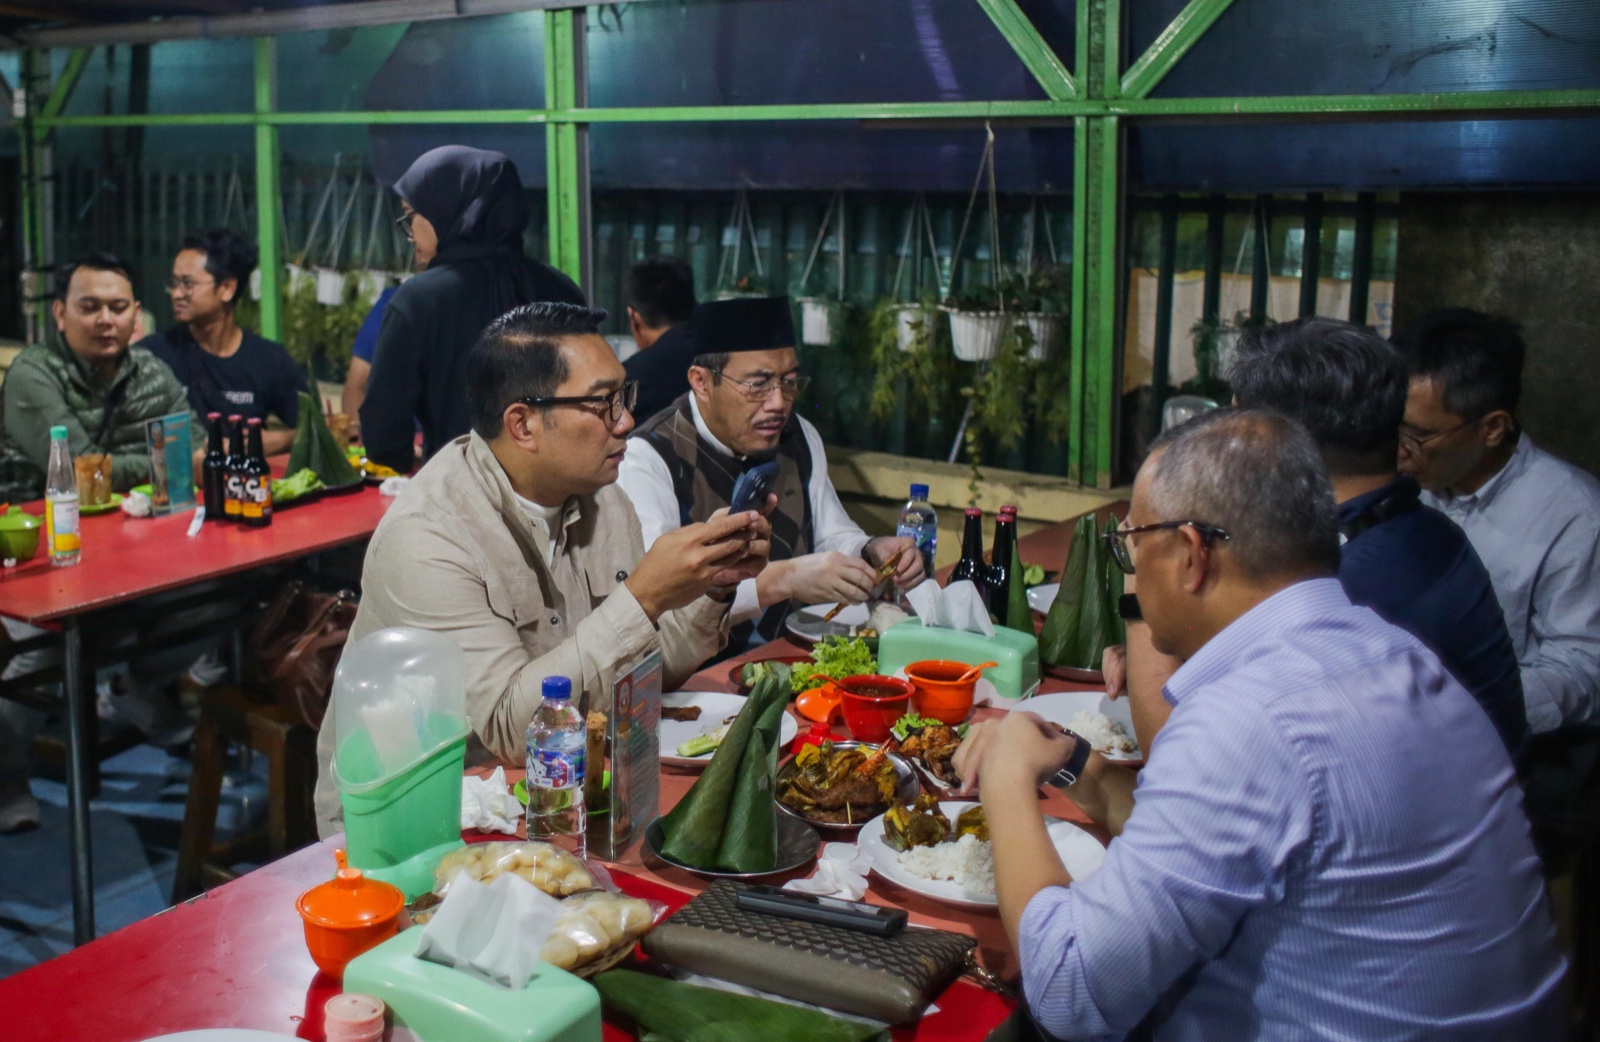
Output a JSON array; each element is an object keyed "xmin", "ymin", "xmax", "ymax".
[{"xmin": 618, "ymin": 296, "xmax": 923, "ymax": 650}]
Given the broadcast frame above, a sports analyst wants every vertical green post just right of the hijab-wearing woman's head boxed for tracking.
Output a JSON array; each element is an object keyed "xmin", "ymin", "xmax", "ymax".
[{"xmin": 544, "ymin": 8, "xmax": 594, "ymax": 291}]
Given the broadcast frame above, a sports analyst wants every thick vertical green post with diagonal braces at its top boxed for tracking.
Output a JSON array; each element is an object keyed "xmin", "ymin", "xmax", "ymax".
[{"xmin": 1067, "ymin": 0, "xmax": 1123, "ymax": 488}]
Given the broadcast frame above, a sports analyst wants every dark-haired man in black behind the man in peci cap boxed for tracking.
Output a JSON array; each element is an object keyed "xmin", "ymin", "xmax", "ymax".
[{"xmin": 622, "ymin": 256, "xmax": 699, "ymax": 423}]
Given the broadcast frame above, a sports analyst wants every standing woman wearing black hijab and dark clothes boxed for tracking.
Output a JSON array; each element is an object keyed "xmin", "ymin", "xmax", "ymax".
[{"xmin": 362, "ymin": 144, "xmax": 586, "ymax": 474}]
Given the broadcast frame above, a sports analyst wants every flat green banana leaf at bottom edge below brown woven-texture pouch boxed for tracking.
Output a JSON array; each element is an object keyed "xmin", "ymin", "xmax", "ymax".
[{"xmin": 594, "ymin": 970, "xmax": 888, "ymax": 1042}]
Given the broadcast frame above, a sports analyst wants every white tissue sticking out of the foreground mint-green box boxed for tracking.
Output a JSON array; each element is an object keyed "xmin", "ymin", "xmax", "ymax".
[{"xmin": 416, "ymin": 871, "xmax": 562, "ymax": 991}]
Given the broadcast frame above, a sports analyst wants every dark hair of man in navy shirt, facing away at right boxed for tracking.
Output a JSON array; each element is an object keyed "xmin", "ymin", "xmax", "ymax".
[{"xmin": 1227, "ymin": 319, "xmax": 1406, "ymax": 474}]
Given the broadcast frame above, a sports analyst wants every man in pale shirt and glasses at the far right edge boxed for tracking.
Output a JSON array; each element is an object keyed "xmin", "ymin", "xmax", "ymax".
[{"xmin": 1394, "ymin": 307, "xmax": 1600, "ymax": 733}]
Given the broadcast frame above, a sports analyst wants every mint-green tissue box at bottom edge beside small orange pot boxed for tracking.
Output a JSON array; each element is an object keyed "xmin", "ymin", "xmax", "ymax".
[{"xmin": 344, "ymin": 928, "xmax": 600, "ymax": 1042}]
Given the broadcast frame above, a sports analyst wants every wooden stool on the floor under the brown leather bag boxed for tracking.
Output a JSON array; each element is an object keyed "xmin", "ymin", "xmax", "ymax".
[{"xmin": 173, "ymin": 685, "xmax": 317, "ymax": 904}]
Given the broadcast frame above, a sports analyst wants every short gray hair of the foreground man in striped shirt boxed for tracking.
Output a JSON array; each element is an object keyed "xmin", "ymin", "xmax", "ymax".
[{"xmin": 1150, "ymin": 408, "xmax": 1339, "ymax": 579}]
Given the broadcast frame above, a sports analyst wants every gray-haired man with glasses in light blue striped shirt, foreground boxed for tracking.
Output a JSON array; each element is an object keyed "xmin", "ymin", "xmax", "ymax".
[{"xmin": 957, "ymin": 410, "xmax": 1565, "ymax": 1042}]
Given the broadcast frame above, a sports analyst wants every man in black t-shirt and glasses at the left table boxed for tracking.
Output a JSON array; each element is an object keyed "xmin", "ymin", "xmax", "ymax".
[{"xmin": 139, "ymin": 229, "xmax": 306, "ymax": 456}]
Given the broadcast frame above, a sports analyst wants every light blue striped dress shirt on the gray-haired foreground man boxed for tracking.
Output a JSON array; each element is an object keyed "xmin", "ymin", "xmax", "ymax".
[{"xmin": 1019, "ymin": 579, "xmax": 1565, "ymax": 1042}]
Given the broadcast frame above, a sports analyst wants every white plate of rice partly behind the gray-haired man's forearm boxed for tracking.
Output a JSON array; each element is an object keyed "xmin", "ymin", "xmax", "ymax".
[{"xmin": 856, "ymin": 800, "xmax": 1106, "ymax": 908}]
